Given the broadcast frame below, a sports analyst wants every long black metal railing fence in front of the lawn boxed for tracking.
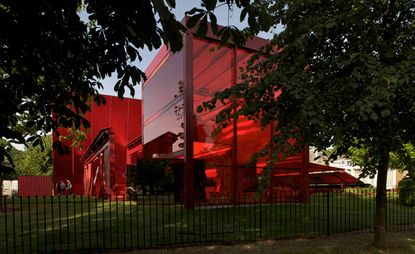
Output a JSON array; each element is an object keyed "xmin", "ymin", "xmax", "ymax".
[{"xmin": 0, "ymin": 189, "xmax": 415, "ymax": 253}]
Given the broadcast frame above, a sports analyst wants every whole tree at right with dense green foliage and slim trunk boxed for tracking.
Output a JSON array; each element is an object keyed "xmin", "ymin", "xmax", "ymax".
[{"xmin": 199, "ymin": 0, "xmax": 415, "ymax": 247}]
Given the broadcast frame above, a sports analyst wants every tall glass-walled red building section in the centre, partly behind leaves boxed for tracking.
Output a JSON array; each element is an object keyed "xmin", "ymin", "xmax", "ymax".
[{"xmin": 142, "ymin": 22, "xmax": 358, "ymax": 207}]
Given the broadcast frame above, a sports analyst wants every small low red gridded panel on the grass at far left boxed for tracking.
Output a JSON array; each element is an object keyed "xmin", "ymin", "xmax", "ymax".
[{"xmin": 18, "ymin": 176, "xmax": 52, "ymax": 197}]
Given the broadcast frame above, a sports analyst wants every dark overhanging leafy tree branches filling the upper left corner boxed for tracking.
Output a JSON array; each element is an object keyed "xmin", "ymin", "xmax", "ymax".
[{"xmin": 0, "ymin": 0, "xmax": 266, "ymax": 174}]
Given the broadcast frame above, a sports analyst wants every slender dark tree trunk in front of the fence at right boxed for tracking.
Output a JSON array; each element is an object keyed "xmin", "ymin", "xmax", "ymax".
[{"xmin": 373, "ymin": 144, "xmax": 389, "ymax": 248}]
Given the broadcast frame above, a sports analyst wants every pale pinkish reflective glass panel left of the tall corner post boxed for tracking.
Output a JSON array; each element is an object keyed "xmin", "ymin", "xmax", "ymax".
[{"xmin": 143, "ymin": 48, "xmax": 184, "ymax": 158}]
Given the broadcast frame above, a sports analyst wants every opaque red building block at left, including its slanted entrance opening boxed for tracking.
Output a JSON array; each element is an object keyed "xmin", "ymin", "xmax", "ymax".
[{"xmin": 53, "ymin": 95, "xmax": 141, "ymax": 195}]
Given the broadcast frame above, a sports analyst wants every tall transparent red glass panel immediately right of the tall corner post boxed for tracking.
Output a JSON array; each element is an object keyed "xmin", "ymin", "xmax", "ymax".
[{"xmin": 193, "ymin": 39, "xmax": 234, "ymax": 198}]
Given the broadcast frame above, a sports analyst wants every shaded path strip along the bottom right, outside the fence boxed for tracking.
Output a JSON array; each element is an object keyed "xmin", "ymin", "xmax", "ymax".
[{"xmin": 101, "ymin": 230, "xmax": 415, "ymax": 254}]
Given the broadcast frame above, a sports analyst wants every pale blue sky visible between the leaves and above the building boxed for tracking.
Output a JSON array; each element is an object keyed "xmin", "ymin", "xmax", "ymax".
[{"xmin": 100, "ymin": 0, "xmax": 271, "ymax": 99}]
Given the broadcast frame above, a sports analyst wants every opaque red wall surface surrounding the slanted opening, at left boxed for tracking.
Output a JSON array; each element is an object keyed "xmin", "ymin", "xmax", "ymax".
[{"xmin": 53, "ymin": 95, "xmax": 141, "ymax": 194}]
